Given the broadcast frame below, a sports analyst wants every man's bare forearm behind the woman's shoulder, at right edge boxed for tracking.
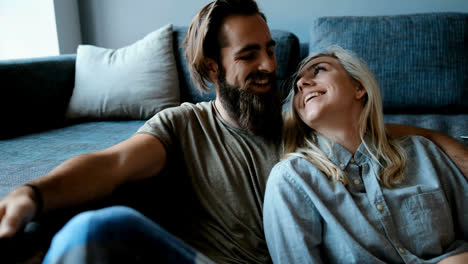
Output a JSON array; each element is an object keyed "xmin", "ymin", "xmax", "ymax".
[{"xmin": 385, "ymin": 124, "xmax": 468, "ymax": 180}]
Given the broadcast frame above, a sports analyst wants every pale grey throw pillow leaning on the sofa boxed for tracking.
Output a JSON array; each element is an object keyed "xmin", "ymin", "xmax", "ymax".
[{"xmin": 66, "ymin": 24, "xmax": 180, "ymax": 119}]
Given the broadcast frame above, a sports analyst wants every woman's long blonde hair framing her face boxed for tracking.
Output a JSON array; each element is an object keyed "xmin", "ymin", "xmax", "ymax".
[{"xmin": 282, "ymin": 46, "xmax": 406, "ymax": 188}]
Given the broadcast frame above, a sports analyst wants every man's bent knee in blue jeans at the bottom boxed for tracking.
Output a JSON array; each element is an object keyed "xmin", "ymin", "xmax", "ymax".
[{"xmin": 43, "ymin": 206, "xmax": 213, "ymax": 264}]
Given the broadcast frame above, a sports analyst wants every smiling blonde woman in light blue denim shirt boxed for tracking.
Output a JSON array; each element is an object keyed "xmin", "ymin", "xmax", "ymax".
[{"xmin": 263, "ymin": 47, "xmax": 468, "ymax": 263}]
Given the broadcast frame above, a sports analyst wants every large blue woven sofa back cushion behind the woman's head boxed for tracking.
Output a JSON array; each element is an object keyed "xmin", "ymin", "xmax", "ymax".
[{"xmin": 309, "ymin": 13, "xmax": 468, "ymax": 114}]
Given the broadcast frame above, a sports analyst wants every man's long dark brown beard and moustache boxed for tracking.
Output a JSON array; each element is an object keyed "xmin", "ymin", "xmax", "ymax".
[{"xmin": 218, "ymin": 67, "xmax": 283, "ymax": 140}]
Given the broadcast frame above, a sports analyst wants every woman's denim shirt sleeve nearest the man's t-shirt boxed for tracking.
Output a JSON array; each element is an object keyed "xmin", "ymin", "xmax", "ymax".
[{"xmin": 263, "ymin": 158, "xmax": 322, "ymax": 263}]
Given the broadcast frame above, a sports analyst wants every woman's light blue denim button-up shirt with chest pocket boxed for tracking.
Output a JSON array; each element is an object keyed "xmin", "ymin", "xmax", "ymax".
[{"xmin": 263, "ymin": 136, "xmax": 468, "ymax": 264}]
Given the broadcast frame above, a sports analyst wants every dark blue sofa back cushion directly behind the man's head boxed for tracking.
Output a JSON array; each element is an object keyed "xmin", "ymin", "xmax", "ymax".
[{"xmin": 174, "ymin": 27, "xmax": 300, "ymax": 103}]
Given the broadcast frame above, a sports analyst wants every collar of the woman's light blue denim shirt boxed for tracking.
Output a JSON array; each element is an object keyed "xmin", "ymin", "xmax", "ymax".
[{"xmin": 316, "ymin": 134, "xmax": 375, "ymax": 170}]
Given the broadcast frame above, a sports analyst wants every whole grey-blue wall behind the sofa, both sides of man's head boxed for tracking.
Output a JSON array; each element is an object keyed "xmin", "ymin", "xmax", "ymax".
[{"xmin": 78, "ymin": 0, "xmax": 468, "ymax": 48}]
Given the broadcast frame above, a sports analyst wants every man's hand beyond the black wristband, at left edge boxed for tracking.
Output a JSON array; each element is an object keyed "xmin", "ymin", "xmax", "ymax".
[{"xmin": 0, "ymin": 186, "xmax": 37, "ymax": 238}]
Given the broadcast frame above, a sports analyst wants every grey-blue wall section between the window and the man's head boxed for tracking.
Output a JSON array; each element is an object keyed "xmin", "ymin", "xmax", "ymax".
[{"xmin": 79, "ymin": 0, "xmax": 211, "ymax": 48}]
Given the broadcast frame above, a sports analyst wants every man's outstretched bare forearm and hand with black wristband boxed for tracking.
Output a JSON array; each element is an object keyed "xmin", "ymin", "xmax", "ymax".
[{"xmin": 0, "ymin": 134, "xmax": 166, "ymax": 238}]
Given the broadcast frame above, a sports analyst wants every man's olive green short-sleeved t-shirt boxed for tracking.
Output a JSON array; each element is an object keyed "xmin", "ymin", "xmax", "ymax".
[{"xmin": 138, "ymin": 101, "xmax": 279, "ymax": 263}]
